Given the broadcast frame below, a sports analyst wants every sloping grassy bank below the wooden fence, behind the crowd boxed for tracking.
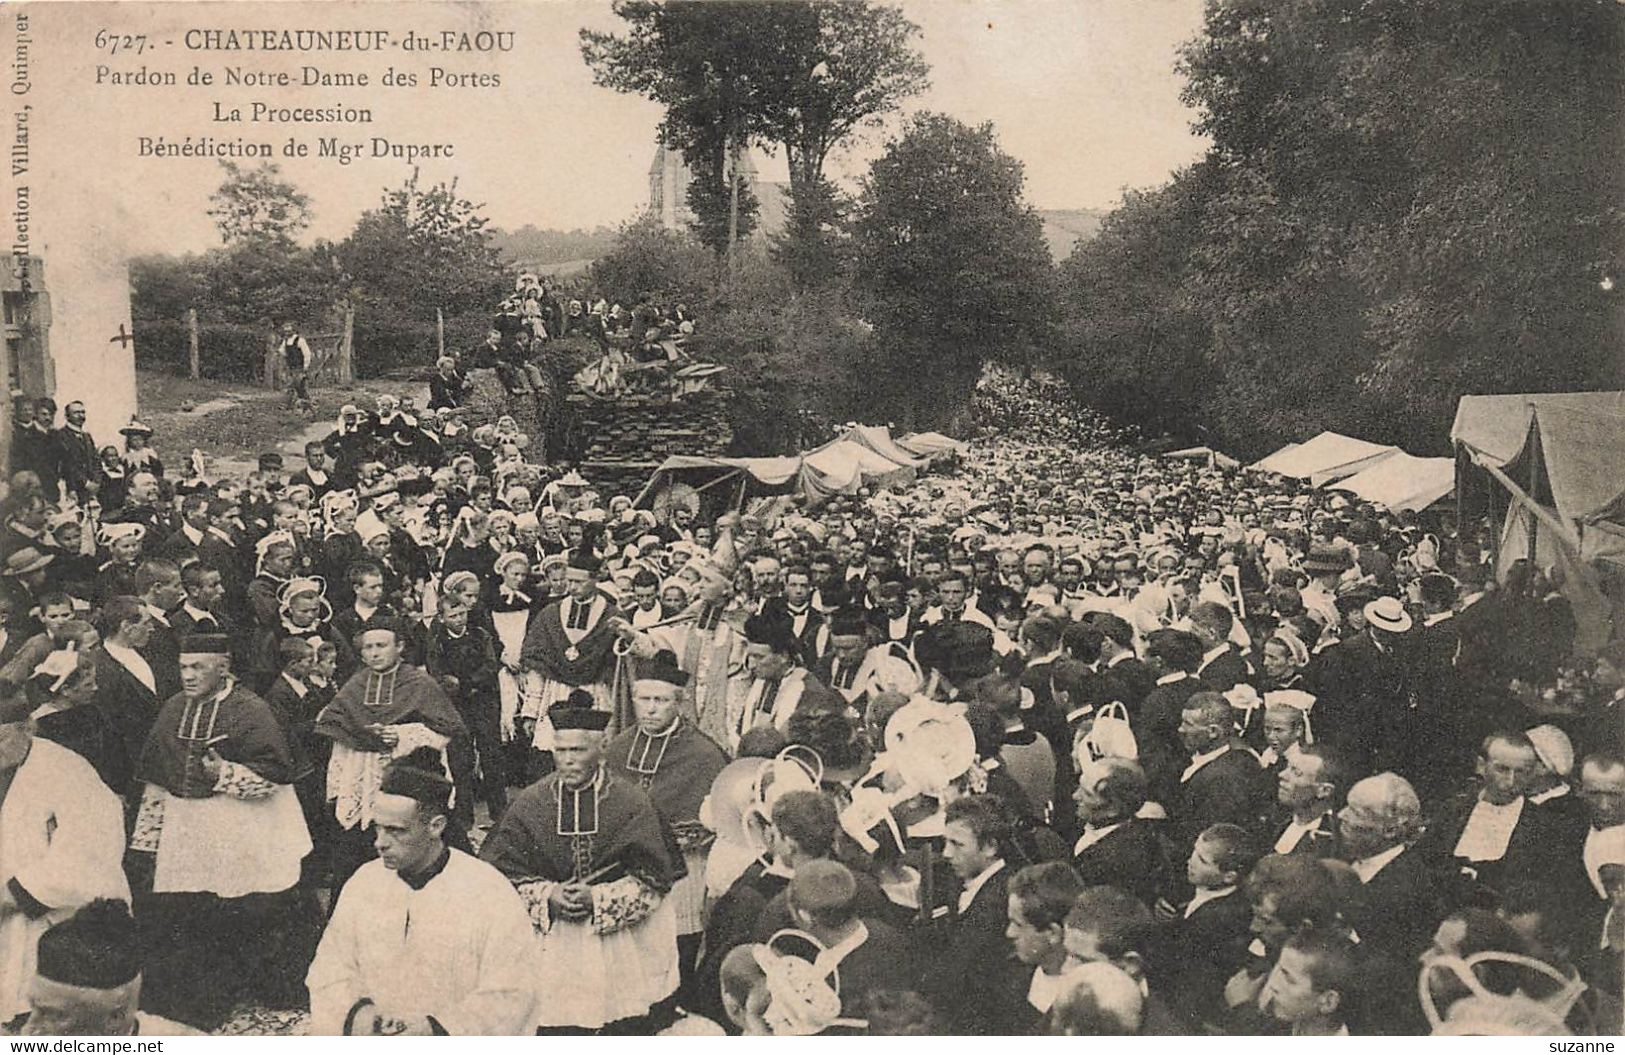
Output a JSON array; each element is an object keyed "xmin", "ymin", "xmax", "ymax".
[{"xmin": 138, "ymin": 371, "xmax": 423, "ymax": 465}]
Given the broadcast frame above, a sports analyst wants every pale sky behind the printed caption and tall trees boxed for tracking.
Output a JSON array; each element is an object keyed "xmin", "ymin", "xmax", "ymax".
[{"xmin": 22, "ymin": 0, "xmax": 1204, "ymax": 255}]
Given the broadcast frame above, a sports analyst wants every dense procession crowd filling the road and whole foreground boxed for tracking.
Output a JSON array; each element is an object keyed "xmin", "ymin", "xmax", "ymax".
[{"xmin": 0, "ymin": 341, "xmax": 1625, "ymax": 1035}]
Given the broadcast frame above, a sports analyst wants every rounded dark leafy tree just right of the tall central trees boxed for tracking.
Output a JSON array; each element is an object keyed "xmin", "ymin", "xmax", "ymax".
[{"xmin": 853, "ymin": 114, "xmax": 1053, "ymax": 426}]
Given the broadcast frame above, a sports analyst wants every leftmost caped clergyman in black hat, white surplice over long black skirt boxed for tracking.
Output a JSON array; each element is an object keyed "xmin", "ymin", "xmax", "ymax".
[{"xmin": 130, "ymin": 634, "xmax": 314, "ymax": 1029}]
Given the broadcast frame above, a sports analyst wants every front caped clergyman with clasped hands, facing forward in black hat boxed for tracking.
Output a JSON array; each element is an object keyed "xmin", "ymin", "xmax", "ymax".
[{"xmin": 479, "ymin": 689, "xmax": 683, "ymax": 1032}]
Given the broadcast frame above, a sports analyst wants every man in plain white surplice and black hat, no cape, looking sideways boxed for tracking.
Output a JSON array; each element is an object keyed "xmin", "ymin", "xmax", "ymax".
[{"xmin": 307, "ymin": 751, "xmax": 536, "ymax": 1037}]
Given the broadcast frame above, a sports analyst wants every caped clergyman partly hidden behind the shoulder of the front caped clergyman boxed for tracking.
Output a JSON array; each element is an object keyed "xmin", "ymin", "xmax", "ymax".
[{"xmin": 606, "ymin": 652, "xmax": 728, "ymax": 985}]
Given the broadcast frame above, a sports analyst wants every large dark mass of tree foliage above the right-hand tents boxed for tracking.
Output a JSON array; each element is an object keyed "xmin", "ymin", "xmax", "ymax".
[{"xmin": 1063, "ymin": 0, "xmax": 1625, "ymax": 454}]
